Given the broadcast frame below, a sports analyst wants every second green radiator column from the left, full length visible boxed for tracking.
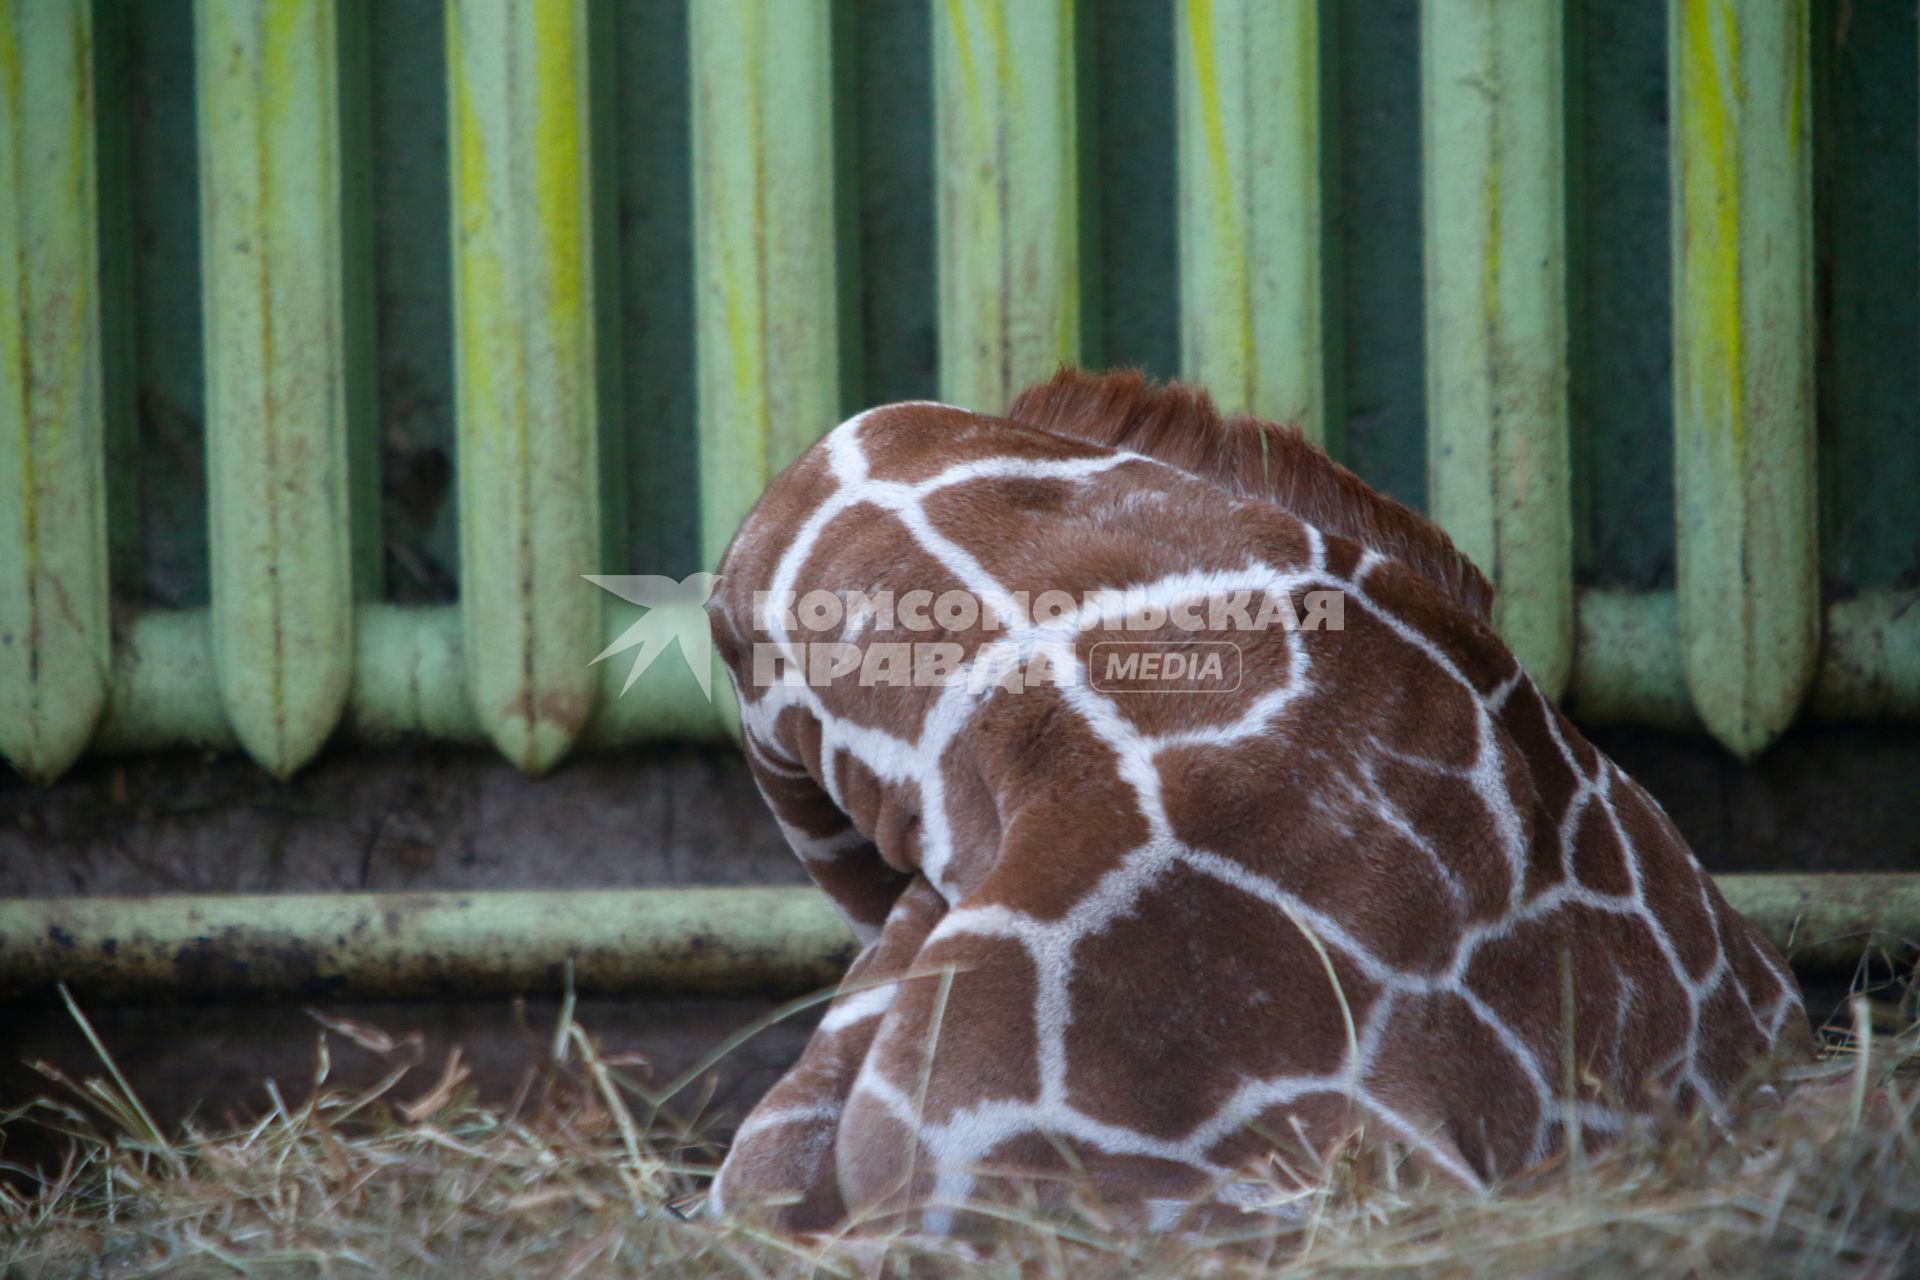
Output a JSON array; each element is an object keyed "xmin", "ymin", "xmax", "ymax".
[{"xmin": 194, "ymin": 0, "xmax": 353, "ymax": 777}]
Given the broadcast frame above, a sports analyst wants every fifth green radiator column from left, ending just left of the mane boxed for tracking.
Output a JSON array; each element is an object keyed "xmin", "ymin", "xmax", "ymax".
[{"xmin": 933, "ymin": 0, "xmax": 1081, "ymax": 413}]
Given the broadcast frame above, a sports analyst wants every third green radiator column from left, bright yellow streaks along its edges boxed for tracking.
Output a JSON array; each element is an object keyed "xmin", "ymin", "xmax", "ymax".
[{"xmin": 447, "ymin": 0, "xmax": 603, "ymax": 773}]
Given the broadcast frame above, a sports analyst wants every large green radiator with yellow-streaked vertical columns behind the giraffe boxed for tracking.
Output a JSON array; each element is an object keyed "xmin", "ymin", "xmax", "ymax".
[{"xmin": 0, "ymin": 0, "xmax": 1920, "ymax": 781}]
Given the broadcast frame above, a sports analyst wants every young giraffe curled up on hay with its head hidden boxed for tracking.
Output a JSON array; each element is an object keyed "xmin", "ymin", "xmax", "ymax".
[{"xmin": 708, "ymin": 370, "xmax": 1809, "ymax": 1230}]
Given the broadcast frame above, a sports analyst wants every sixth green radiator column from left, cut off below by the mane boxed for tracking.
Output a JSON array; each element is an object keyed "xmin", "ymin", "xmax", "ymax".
[{"xmin": 1173, "ymin": 0, "xmax": 1331, "ymax": 443}]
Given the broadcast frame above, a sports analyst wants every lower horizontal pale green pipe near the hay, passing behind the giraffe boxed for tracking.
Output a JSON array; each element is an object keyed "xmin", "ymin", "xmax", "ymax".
[{"xmin": 0, "ymin": 875, "xmax": 1920, "ymax": 998}]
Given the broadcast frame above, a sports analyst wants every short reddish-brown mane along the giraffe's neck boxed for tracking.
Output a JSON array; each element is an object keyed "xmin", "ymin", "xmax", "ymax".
[{"xmin": 1006, "ymin": 367, "xmax": 1494, "ymax": 622}]
